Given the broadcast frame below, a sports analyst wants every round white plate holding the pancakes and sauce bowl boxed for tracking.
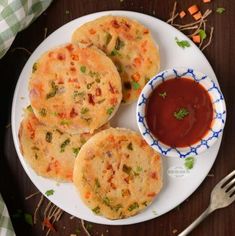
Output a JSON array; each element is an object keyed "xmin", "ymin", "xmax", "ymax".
[{"xmin": 12, "ymin": 11, "xmax": 221, "ymax": 225}]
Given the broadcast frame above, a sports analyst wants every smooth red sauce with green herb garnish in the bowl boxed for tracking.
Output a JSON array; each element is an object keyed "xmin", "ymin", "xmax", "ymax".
[{"xmin": 146, "ymin": 78, "xmax": 213, "ymax": 147}]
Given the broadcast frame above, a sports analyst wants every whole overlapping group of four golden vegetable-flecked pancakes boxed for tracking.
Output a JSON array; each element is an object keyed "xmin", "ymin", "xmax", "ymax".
[{"xmin": 19, "ymin": 16, "xmax": 162, "ymax": 219}]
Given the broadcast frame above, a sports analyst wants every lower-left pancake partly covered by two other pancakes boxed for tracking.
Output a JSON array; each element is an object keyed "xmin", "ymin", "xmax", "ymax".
[{"xmin": 19, "ymin": 107, "xmax": 109, "ymax": 182}]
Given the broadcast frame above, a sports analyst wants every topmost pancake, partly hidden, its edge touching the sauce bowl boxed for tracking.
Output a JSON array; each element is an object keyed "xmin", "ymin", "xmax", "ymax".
[{"xmin": 72, "ymin": 16, "xmax": 160, "ymax": 103}]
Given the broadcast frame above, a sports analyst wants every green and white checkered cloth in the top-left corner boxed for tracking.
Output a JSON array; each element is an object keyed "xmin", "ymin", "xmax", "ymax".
[{"xmin": 0, "ymin": 0, "xmax": 52, "ymax": 58}]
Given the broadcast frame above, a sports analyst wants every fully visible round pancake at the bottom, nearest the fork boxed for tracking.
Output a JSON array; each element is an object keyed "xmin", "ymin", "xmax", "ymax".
[{"xmin": 73, "ymin": 128, "xmax": 162, "ymax": 219}]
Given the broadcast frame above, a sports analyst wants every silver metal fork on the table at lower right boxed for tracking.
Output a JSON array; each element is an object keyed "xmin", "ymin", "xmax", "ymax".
[{"xmin": 178, "ymin": 170, "xmax": 235, "ymax": 236}]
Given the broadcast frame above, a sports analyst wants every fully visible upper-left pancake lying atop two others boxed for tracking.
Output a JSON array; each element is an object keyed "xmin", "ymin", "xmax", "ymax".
[{"xmin": 29, "ymin": 44, "xmax": 122, "ymax": 134}]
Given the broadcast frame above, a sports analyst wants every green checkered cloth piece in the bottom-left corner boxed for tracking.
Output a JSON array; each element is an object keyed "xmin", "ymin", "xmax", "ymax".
[{"xmin": 0, "ymin": 194, "xmax": 15, "ymax": 236}]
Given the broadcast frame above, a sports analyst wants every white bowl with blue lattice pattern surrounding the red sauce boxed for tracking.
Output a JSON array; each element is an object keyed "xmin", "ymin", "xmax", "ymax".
[{"xmin": 136, "ymin": 68, "xmax": 226, "ymax": 158}]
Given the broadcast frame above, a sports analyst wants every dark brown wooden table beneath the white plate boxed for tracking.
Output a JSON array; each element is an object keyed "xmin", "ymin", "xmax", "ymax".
[{"xmin": 0, "ymin": 0, "xmax": 235, "ymax": 236}]
